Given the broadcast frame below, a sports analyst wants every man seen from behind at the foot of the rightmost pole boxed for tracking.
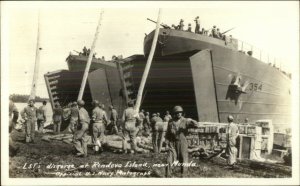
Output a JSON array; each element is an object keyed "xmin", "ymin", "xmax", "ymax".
[{"xmin": 122, "ymin": 101, "xmax": 141, "ymax": 153}]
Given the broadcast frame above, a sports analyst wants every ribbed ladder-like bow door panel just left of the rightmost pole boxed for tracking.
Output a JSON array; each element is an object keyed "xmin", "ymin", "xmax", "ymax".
[{"xmin": 116, "ymin": 61, "xmax": 136, "ymax": 105}]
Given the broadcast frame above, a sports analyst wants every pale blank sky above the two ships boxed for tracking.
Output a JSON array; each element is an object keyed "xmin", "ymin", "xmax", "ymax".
[{"xmin": 1, "ymin": 1, "xmax": 299, "ymax": 97}]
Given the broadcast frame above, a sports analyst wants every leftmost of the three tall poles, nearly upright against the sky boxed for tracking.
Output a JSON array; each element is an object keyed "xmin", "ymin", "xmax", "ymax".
[{"xmin": 29, "ymin": 11, "xmax": 42, "ymax": 99}]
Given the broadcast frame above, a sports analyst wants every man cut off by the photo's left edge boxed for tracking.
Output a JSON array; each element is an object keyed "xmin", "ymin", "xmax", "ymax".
[{"xmin": 9, "ymin": 97, "xmax": 19, "ymax": 156}]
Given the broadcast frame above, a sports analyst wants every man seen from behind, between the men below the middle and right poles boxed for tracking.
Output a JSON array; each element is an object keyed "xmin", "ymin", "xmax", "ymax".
[{"xmin": 92, "ymin": 100, "xmax": 107, "ymax": 153}]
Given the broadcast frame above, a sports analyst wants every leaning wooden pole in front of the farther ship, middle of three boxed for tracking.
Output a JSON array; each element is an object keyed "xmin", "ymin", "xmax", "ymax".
[{"xmin": 78, "ymin": 11, "xmax": 103, "ymax": 100}]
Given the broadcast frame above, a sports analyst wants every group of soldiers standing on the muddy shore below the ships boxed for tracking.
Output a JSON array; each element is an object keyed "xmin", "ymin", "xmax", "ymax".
[{"xmin": 9, "ymin": 97, "xmax": 238, "ymax": 176}]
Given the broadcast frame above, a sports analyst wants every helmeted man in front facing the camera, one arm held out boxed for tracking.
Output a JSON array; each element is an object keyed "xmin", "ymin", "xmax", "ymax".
[{"xmin": 166, "ymin": 106, "xmax": 198, "ymax": 177}]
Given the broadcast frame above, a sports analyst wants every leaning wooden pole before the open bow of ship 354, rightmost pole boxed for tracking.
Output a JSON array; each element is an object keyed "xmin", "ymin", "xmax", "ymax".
[{"xmin": 135, "ymin": 9, "xmax": 161, "ymax": 112}]
